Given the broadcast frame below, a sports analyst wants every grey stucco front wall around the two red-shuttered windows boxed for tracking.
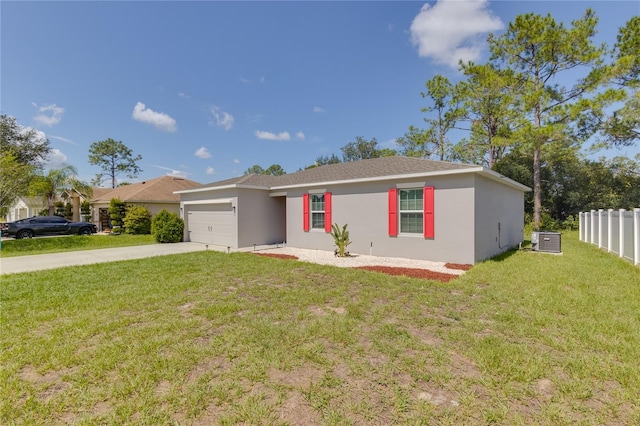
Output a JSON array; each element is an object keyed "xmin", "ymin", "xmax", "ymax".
[{"xmin": 286, "ymin": 175, "xmax": 475, "ymax": 263}]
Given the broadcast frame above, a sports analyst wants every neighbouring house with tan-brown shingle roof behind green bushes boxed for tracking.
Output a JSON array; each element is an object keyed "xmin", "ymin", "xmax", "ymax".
[{"xmin": 91, "ymin": 176, "xmax": 202, "ymax": 231}]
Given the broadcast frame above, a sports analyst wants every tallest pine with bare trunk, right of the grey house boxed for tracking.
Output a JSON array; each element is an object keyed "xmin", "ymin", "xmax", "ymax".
[{"xmin": 489, "ymin": 9, "xmax": 604, "ymax": 229}]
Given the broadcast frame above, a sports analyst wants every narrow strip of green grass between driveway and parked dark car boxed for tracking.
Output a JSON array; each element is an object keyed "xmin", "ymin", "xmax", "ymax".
[{"xmin": 0, "ymin": 234, "xmax": 156, "ymax": 257}]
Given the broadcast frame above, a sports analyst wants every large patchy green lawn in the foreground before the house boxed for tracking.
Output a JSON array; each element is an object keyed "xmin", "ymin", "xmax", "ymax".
[{"xmin": 0, "ymin": 234, "xmax": 640, "ymax": 425}]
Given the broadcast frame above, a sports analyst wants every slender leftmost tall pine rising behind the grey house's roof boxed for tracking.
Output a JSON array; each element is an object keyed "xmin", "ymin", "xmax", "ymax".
[{"xmin": 420, "ymin": 75, "xmax": 462, "ymax": 161}]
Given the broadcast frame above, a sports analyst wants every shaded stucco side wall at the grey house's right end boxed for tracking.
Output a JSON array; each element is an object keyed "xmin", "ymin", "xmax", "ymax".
[{"xmin": 474, "ymin": 175, "xmax": 524, "ymax": 261}]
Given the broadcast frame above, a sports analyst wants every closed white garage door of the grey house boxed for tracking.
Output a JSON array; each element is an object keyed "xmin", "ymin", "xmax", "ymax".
[{"xmin": 188, "ymin": 203, "xmax": 236, "ymax": 248}]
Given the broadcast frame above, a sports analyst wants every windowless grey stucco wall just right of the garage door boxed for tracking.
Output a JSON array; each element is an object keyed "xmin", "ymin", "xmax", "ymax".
[{"xmin": 236, "ymin": 188, "xmax": 287, "ymax": 247}]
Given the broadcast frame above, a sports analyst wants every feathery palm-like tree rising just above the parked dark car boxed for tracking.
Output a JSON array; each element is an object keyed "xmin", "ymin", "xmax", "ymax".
[{"xmin": 30, "ymin": 165, "xmax": 91, "ymax": 215}]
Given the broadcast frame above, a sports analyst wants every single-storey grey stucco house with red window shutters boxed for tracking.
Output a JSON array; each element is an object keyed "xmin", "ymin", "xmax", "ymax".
[{"xmin": 178, "ymin": 156, "xmax": 529, "ymax": 264}]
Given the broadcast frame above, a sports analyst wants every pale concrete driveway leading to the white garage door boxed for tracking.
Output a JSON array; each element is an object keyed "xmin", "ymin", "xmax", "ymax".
[{"xmin": 0, "ymin": 242, "xmax": 212, "ymax": 275}]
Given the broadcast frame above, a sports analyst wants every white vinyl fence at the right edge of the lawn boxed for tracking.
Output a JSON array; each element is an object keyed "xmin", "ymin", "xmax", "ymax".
[{"xmin": 580, "ymin": 209, "xmax": 640, "ymax": 265}]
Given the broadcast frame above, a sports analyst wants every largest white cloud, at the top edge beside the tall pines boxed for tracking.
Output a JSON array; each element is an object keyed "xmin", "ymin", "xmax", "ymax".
[{"xmin": 410, "ymin": 0, "xmax": 504, "ymax": 69}]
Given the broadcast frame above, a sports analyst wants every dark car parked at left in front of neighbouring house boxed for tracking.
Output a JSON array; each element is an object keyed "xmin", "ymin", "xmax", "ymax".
[{"xmin": 0, "ymin": 216, "xmax": 98, "ymax": 239}]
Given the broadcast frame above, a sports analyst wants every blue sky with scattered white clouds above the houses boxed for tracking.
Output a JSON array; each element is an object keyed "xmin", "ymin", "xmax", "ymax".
[{"xmin": 0, "ymin": 0, "xmax": 640, "ymax": 183}]
